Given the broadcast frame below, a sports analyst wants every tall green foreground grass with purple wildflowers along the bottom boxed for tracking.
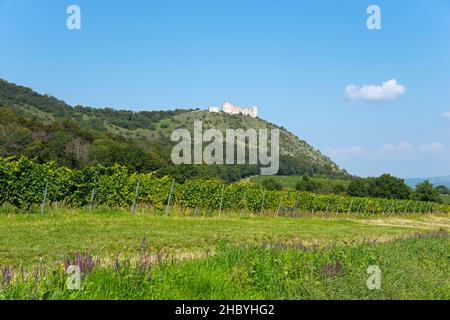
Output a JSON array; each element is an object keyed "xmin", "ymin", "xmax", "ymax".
[{"xmin": 0, "ymin": 231, "xmax": 450, "ymax": 299}]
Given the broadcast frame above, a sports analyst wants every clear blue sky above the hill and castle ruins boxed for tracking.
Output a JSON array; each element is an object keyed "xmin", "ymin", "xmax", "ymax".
[{"xmin": 0, "ymin": 0, "xmax": 450, "ymax": 177}]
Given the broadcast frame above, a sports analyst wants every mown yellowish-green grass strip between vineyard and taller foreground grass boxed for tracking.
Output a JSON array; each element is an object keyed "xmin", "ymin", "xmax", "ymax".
[{"xmin": 0, "ymin": 209, "xmax": 450, "ymax": 265}]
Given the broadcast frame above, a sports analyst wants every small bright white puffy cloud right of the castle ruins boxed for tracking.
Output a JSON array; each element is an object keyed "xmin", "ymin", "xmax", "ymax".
[{"xmin": 344, "ymin": 79, "xmax": 406, "ymax": 103}]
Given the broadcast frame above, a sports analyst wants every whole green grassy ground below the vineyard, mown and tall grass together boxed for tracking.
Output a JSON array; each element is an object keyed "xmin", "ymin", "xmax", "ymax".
[{"xmin": 0, "ymin": 209, "xmax": 450, "ymax": 299}]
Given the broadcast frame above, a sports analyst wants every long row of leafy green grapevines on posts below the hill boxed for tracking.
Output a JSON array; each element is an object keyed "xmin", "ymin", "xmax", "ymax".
[{"xmin": 0, "ymin": 157, "xmax": 450, "ymax": 215}]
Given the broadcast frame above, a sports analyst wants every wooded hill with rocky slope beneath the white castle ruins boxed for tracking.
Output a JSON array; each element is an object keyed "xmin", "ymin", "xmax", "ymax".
[{"xmin": 0, "ymin": 79, "xmax": 348, "ymax": 181}]
